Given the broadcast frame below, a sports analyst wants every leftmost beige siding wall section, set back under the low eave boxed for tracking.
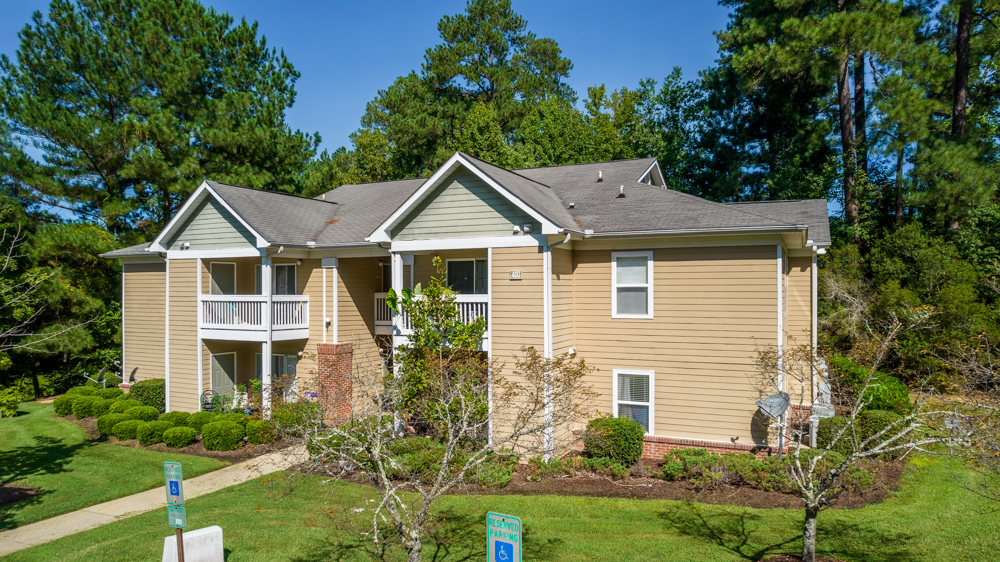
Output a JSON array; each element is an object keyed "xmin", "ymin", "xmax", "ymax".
[{"xmin": 122, "ymin": 263, "xmax": 167, "ymax": 380}]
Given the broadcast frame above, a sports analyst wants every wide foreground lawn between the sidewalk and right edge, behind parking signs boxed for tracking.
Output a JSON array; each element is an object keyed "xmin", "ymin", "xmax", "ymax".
[{"xmin": 5, "ymin": 452, "xmax": 1000, "ymax": 562}]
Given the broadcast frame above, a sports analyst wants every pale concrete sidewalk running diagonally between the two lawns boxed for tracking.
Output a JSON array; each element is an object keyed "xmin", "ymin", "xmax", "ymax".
[{"xmin": 0, "ymin": 447, "xmax": 305, "ymax": 556}]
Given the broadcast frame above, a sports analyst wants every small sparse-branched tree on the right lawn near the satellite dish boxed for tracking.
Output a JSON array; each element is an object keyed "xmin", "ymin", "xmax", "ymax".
[{"xmin": 754, "ymin": 312, "xmax": 964, "ymax": 562}]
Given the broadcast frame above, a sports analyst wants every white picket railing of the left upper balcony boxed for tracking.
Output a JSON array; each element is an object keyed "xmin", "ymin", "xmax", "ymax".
[{"xmin": 198, "ymin": 295, "xmax": 309, "ymax": 332}]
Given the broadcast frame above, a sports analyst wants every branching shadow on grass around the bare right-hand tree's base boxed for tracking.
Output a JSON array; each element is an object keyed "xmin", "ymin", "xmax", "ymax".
[{"xmin": 659, "ymin": 502, "xmax": 914, "ymax": 562}]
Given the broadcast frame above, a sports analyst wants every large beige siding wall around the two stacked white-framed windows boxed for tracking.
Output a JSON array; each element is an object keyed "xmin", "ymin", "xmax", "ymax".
[{"xmin": 573, "ymin": 245, "xmax": 778, "ymax": 443}]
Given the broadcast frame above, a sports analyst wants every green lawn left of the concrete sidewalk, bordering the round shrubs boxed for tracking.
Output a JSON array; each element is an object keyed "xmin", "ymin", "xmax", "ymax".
[{"xmin": 0, "ymin": 402, "xmax": 227, "ymax": 531}]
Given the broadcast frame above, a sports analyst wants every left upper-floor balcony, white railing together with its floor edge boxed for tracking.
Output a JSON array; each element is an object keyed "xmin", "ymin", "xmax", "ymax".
[{"xmin": 198, "ymin": 295, "xmax": 309, "ymax": 342}]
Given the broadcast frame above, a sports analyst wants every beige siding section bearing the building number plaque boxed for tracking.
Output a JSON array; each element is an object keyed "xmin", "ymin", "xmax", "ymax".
[{"xmin": 490, "ymin": 247, "xmax": 544, "ymax": 360}]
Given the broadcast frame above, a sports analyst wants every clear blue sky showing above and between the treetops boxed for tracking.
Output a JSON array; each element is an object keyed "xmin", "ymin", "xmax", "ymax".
[{"xmin": 0, "ymin": 0, "xmax": 727, "ymax": 150}]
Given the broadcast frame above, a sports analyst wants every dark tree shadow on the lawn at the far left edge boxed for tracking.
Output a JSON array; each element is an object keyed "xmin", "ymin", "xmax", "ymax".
[{"xmin": 0, "ymin": 430, "xmax": 94, "ymax": 531}]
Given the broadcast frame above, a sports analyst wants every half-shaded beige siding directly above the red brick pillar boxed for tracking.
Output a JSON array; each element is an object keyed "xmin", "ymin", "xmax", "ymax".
[{"xmin": 337, "ymin": 257, "xmax": 388, "ymax": 361}]
